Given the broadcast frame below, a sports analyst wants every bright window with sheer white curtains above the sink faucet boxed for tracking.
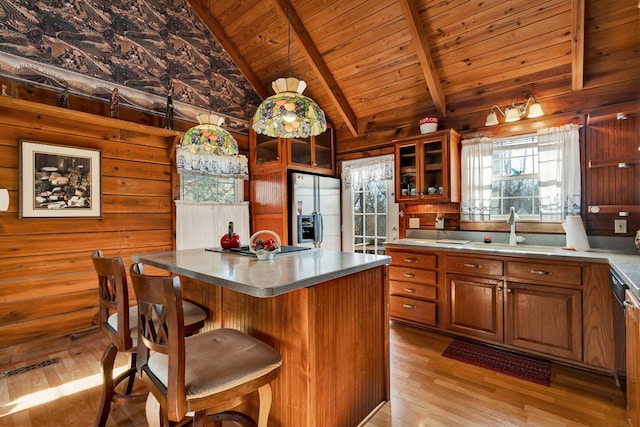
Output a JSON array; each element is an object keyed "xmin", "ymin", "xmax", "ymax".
[{"xmin": 460, "ymin": 125, "xmax": 581, "ymax": 222}]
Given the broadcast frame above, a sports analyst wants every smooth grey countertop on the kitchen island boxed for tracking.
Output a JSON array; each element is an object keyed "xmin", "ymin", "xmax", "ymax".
[{"xmin": 131, "ymin": 248, "xmax": 391, "ymax": 297}]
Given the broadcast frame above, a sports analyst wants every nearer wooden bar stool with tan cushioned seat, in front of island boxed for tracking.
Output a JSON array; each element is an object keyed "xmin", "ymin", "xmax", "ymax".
[{"xmin": 129, "ymin": 264, "xmax": 282, "ymax": 427}]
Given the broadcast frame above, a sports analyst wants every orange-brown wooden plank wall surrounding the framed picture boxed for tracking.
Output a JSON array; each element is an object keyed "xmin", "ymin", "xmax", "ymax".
[{"xmin": 0, "ymin": 97, "xmax": 181, "ymax": 365}]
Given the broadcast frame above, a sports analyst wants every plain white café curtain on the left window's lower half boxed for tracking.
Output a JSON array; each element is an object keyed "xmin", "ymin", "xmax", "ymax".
[{"xmin": 175, "ymin": 200, "xmax": 251, "ymax": 250}]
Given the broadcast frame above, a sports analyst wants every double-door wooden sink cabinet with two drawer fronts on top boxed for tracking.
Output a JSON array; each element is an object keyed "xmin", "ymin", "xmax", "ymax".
[{"xmin": 446, "ymin": 256, "xmax": 582, "ymax": 361}]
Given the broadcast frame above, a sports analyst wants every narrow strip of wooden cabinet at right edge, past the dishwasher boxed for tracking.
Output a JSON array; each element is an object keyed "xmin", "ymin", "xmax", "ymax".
[{"xmin": 624, "ymin": 291, "xmax": 640, "ymax": 426}]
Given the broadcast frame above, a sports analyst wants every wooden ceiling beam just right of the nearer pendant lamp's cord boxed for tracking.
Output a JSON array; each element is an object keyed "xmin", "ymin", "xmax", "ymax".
[{"xmin": 271, "ymin": 0, "xmax": 358, "ymax": 136}]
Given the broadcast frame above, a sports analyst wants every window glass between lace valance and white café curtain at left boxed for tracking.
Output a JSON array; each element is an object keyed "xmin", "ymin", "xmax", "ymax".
[{"xmin": 180, "ymin": 173, "xmax": 244, "ymax": 204}]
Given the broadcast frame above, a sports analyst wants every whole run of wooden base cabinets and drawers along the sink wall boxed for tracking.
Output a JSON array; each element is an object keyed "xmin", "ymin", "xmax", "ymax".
[{"xmin": 386, "ymin": 244, "xmax": 616, "ymax": 374}]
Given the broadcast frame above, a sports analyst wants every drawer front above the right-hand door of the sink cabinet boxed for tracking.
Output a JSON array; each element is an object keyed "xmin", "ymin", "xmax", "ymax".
[{"xmin": 507, "ymin": 261, "xmax": 582, "ymax": 286}]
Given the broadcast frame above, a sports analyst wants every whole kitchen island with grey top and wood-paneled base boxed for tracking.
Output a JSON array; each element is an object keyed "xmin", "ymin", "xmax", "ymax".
[{"xmin": 131, "ymin": 249, "xmax": 390, "ymax": 427}]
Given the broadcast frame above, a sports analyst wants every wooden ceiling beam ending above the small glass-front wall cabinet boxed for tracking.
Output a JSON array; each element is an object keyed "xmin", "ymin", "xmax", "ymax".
[{"xmin": 398, "ymin": 0, "xmax": 448, "ymax": 118}]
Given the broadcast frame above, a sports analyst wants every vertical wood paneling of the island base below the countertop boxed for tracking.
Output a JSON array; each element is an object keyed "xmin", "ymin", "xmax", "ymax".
[{"xmin": 175, "ymin": 266, "xmax": 390, "ymax": 427}]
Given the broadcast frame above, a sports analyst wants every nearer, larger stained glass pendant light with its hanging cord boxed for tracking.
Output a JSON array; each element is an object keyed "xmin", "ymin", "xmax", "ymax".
[{"xmin": 252, "ymin": 2, "xmax": 327, "ymax": 138}]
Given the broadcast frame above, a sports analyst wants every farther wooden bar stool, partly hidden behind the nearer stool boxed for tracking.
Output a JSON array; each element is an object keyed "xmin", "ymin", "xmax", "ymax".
[{"xmin": 91, "ymin": 251, "xmax": 207, "ymax": 427}]
